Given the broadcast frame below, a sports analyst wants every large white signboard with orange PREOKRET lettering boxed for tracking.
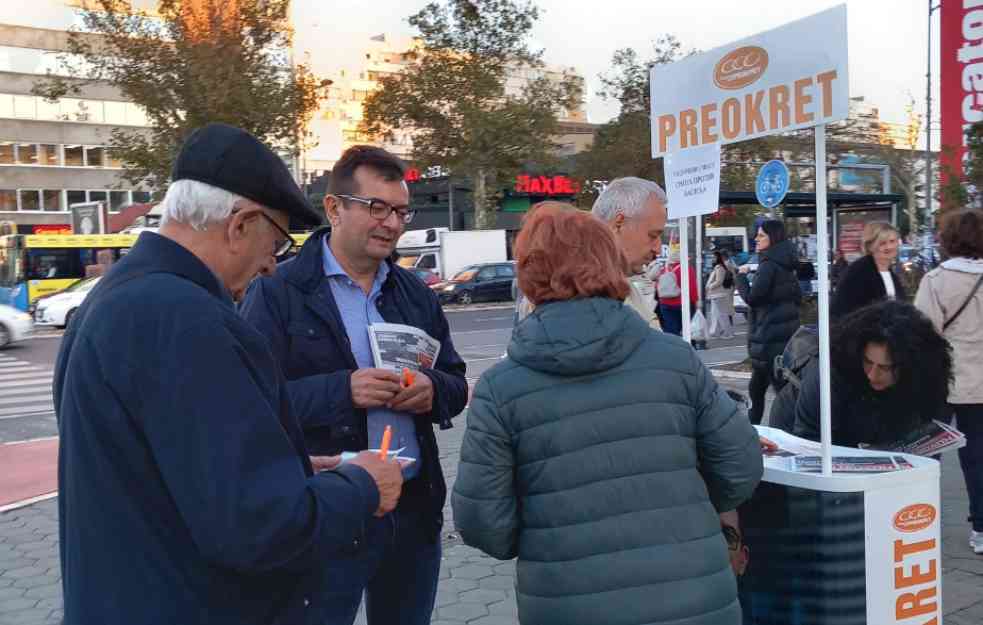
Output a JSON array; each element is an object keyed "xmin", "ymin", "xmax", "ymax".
[{"xmin": 650, "ymin": 5, "xmax": 849, "ymax": 158}]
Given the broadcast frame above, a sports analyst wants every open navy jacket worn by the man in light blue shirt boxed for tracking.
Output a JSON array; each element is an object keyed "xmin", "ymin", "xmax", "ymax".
[{"xmin": 240, "ymin": 229, "xmax": 468, "ymax": 539}]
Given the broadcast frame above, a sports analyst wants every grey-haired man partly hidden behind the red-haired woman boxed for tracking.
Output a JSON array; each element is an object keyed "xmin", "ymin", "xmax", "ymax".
[{"xmin": 591, "ymin": 177, "xmax": 668, "ymax": 328}]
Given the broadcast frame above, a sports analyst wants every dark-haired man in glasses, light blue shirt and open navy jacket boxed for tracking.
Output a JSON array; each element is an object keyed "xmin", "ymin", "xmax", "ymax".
[{"xmin": 241, "ymin": 146, "xmax": 468, "ymax": 625}]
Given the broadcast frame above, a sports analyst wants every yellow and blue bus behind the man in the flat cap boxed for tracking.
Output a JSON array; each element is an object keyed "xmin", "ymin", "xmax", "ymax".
[{"xmin": 0, "ymin": 234, "xmax": 138, "ymax": 310}]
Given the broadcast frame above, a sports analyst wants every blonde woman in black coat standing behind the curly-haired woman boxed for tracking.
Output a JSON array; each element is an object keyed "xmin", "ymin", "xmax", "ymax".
[{"xmin": 829, "ymin": 221, "xmax": 906, "ymax": 319}]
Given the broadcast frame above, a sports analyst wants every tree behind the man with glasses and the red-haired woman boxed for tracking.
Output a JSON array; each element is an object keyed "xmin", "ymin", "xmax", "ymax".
[{"xmin": 361, "ymin": 0, "xmax": 583, "ymax": 229}]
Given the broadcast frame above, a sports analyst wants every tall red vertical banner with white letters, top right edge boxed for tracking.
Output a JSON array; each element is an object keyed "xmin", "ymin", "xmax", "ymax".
[{"xmin": 939, "ymin": 0, "xmax": 983, "ymax": 182}]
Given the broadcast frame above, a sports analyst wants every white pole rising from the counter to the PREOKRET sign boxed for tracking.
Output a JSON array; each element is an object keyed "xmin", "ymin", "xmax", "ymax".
[{"xmin": 815, "ymin": 124, "xmax": 833, "ymax": 475}]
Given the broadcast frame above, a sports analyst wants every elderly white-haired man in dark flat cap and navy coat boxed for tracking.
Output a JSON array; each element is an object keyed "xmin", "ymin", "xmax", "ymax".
[{"xmin": 49, "ymin": 124, "xmax": 402, "ymax": 625}]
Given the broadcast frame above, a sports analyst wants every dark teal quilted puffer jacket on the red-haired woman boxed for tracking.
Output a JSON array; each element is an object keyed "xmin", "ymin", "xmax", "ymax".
[{"xmin": 452, "ymin": 298, "xmax": 762, "ymax": 625}]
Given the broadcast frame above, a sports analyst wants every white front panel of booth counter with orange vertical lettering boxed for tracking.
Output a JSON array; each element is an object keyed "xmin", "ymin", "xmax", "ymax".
[{"xmin": 864, "ymin": 481, "xmax": 942, "ymax": 625}]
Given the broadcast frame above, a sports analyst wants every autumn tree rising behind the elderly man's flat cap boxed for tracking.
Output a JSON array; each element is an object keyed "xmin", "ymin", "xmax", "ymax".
[{"xmin": 34, "ymin": 0, "xmax": 330, "ymax": 194}]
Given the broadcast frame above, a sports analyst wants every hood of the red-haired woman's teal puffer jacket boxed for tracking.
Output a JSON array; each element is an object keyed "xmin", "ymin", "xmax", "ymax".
[{"xmin": 508, "ymin": 297, "xmax": 651, "ymax": 375}]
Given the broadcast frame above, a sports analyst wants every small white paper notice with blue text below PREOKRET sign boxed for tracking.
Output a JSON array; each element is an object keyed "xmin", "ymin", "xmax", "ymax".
[{"xmin": 665, "ymin": 143, "xmax": 720, "ymax": 219}]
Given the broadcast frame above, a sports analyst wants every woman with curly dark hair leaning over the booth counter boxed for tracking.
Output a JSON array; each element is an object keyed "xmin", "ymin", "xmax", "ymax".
[{"xmin": 793, "ymin": 300, "xmax": 952, "ymax": 448}]
